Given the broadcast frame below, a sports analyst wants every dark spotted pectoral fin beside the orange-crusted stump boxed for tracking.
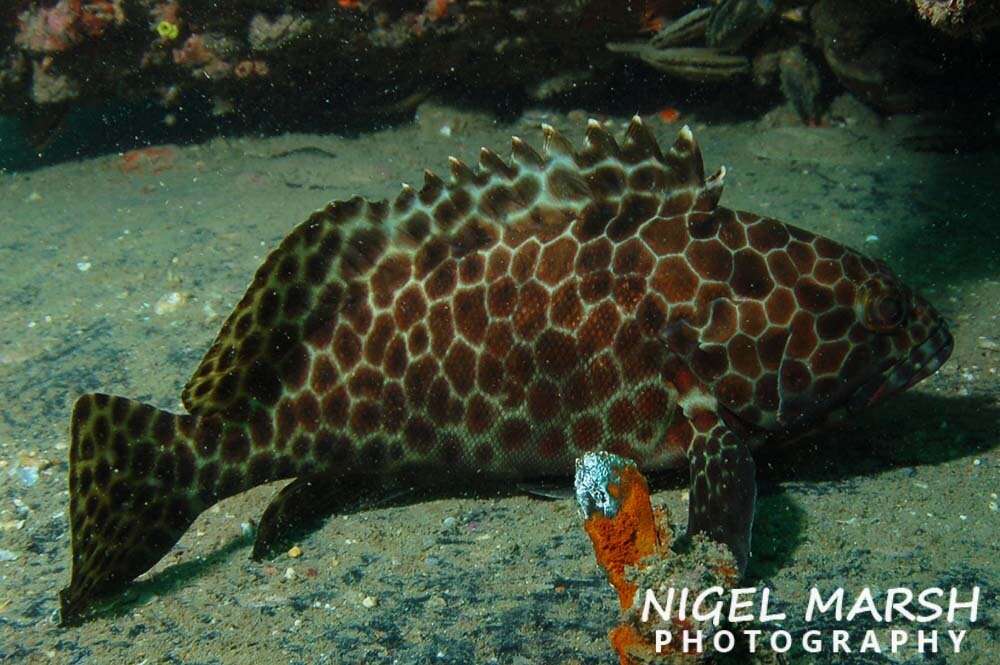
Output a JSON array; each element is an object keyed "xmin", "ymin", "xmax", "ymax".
[{"xmin": 688, "ymin": 420, "xmax": 757, "ymax": 574}]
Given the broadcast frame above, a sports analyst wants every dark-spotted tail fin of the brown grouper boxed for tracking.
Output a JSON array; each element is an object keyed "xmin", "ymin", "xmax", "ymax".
[{"xmin": 60, "ymin": 394, "xmax": 209, "ymax": 624}]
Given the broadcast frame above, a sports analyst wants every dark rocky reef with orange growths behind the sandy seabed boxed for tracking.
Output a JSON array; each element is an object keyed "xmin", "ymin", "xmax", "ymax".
[{"xmin": 0, "ymin": 0, "xmax": 1000, "ymax": 166}]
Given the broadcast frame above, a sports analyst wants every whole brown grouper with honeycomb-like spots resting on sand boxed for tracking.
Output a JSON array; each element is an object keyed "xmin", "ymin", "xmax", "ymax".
[{"xmin": 61, "ymin": 117, "xmax": 953, "ymax": 622}]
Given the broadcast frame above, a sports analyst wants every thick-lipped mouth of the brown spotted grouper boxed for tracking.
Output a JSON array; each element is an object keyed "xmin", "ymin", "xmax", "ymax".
[{"xmin": 847, "ymin": 323, "xmax": 955, "ymax": 413}]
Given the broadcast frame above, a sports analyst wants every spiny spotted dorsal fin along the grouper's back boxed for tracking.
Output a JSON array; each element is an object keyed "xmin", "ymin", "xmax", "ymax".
[{"xmin": 182, "ymin": 122, "xmax": 725, "ymax": 418}]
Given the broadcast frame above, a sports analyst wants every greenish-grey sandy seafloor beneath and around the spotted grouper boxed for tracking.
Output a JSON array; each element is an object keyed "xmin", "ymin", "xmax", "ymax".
[{"xmin": 0, "ymin": 100, "xmax": 1000, "ymax": 665}]
